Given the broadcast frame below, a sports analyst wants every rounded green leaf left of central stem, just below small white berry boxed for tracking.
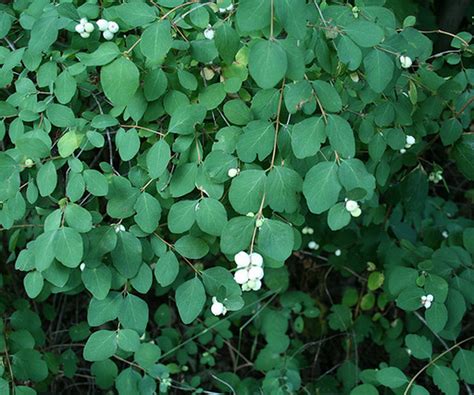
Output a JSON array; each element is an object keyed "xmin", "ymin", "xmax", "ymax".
[{"xmin": 229, "ymin": 170, "xmax": 266, "ymax": 214}]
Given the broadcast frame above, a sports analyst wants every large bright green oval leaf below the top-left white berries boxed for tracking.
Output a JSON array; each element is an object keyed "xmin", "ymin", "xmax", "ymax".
[{"xmin": 100, "ymin": 57, "xmax": 140, "ymax": 106}]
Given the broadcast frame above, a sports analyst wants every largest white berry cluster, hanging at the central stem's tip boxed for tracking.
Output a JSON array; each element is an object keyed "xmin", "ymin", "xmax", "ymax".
[{"xmin": 234, "ymin": 251, "xmax": 264, "ymax": 291}]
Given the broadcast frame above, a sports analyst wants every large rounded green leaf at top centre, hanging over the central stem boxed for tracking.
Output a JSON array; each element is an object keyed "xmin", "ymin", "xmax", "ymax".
[{"xmin": 248, "ymin": 39, "xmax": 288, "ymax": 89}]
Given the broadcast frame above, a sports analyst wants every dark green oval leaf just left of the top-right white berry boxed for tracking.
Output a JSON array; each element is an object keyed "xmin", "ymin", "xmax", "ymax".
[{"xmin": 364, "ymin": 49, "xmax": 395, "ymax": 93}]
